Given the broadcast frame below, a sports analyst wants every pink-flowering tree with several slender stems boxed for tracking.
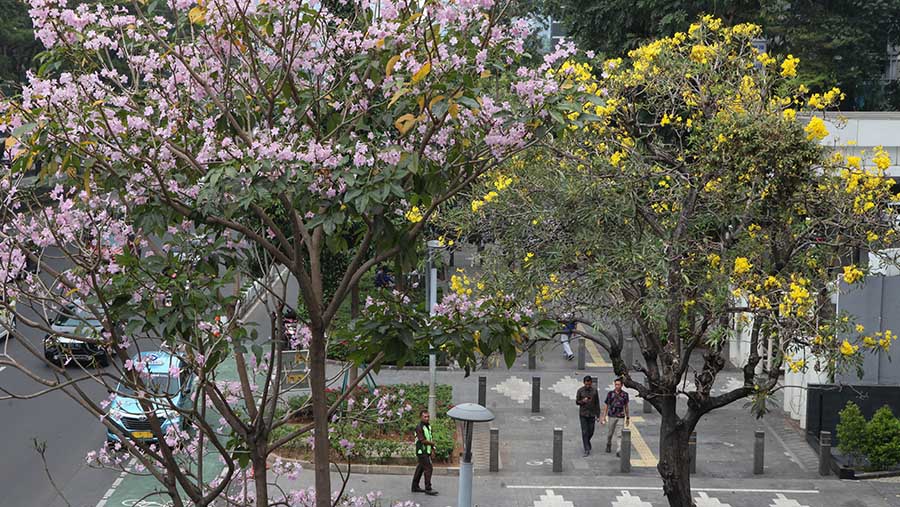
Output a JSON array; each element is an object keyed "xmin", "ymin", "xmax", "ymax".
[{"xmin": 0, "ymin": 0, "xmax": 570, "ymax": 507}]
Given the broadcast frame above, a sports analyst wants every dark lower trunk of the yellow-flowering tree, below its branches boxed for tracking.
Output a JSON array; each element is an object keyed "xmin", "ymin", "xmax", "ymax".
[{"xmin": 656, "ymin": 412, "xmax": 694, "ymax": 507}]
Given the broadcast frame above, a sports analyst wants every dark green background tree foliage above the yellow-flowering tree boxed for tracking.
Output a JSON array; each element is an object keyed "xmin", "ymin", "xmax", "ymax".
[{"xmin": 544, "ymin": 0, "xmax": 900, "ymax": 110}]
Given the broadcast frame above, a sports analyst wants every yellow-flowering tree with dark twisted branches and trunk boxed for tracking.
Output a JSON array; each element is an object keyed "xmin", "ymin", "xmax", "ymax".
[{"xmin": 446, "ymin": 17, "xmax": 895, "ymax": 506}]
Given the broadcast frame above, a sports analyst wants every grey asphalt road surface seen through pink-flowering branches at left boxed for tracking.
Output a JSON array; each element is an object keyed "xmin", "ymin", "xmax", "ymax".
[{"xmin": 0, "ymin": 247, "xmax": 298, "ymax": 507}]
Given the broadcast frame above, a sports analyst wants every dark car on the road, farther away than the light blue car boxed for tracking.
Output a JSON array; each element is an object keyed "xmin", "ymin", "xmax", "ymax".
[{"xmin": 44, "ymin": 303, "xmax": 109, "ymax": 367}]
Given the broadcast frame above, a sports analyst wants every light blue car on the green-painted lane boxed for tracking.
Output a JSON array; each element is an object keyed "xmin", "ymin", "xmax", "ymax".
[{"xmin": 106, "ymin": 351, "xmax": 194, "ymax": 444}]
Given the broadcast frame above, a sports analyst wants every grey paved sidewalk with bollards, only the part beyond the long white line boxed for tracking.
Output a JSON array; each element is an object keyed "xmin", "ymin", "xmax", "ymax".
[{"xmin": 331, "ymin": 340, "xmax": 818, "ymax": 480}]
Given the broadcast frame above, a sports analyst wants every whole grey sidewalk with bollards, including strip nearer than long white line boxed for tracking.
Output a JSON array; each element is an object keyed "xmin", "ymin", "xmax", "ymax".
[{"xmin": 304, "ymin": 344, "xmax": 900, "ymax": 507}]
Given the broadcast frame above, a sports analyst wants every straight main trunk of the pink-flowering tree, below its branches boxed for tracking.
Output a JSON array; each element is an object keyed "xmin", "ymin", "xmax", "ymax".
[{"xmin": 309, "ymin": 329, "xmax": 331, "ymax": 507}]
